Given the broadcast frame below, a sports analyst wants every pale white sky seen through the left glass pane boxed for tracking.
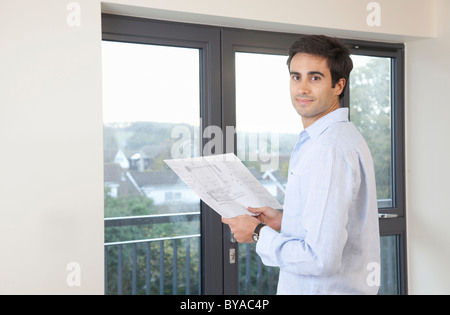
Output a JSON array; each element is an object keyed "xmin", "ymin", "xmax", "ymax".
[{"xmin": 102, "ymin": 41, "xmax": 200, "ymax": 125}]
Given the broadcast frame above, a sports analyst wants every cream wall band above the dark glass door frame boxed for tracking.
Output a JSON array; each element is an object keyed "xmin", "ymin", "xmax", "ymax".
[{"xmin": 102, "ymin": 0, "xmax": 435, "ymax": 41}]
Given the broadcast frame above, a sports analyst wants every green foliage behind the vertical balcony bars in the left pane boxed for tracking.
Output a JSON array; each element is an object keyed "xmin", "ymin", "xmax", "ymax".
[{"xmin": 105, "ymin": 238, "xmax": 200, "ymax": 295}]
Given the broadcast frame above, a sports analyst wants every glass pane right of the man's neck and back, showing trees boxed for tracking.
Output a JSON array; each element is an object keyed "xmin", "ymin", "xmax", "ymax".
[{"xmin": 350, "ymin": 55, "xmax": 393, "ymax": 208}]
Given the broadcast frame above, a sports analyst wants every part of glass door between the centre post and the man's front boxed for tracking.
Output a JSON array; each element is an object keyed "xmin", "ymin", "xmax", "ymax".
[{"xmin": 222, "ymin": 30, "xmax": 303, "ymax": 295}]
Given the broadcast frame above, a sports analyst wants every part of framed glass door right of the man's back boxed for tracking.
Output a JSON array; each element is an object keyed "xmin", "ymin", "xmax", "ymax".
[{"xmin": 349, "ymin": 53, "xmax": 406, "ymax": 295}]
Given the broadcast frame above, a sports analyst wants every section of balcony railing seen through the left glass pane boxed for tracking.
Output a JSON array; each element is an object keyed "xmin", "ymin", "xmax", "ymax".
[{"xmin": 105, "ymin": 212, "xmax": 201, "ymax": 295}]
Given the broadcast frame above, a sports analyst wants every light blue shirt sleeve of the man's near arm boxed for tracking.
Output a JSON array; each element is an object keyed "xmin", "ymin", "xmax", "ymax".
[{"xmin": 256, "ymin": 145, "xmax": 355, "ymax": 276}]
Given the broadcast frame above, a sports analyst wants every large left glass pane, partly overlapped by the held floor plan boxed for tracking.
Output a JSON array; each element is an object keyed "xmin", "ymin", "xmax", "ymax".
[{"xmin": 103, "ymin": 41, "xmax": 200, "ymax": 294}]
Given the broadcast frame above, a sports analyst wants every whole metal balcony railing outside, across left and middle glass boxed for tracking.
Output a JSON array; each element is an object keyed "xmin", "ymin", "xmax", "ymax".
[{"xmin": 105, "ymin": 212, "xmax": 278, "ymax": 295}]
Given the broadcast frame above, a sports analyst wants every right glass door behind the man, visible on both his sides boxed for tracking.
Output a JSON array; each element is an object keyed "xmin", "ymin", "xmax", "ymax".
[{"xmin": 222, "ymin": 31, "xmax": 406, "ymax": 294}]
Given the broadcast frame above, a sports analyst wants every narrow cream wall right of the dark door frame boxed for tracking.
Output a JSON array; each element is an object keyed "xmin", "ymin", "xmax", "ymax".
[{"xmin": 406, "ymin": 0, "xmax": 450, "ymax": 294}]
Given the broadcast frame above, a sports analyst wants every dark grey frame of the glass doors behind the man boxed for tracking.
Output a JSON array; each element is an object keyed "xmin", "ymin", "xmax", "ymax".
[{"xmin": 102, "ymin": 14, "xmax": 407, "ymax": 294}]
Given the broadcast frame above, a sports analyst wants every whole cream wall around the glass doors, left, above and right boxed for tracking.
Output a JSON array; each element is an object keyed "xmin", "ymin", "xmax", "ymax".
[{"xmin": 0, "ymin": 0, "xmax": 450, "ymax": 294}]
